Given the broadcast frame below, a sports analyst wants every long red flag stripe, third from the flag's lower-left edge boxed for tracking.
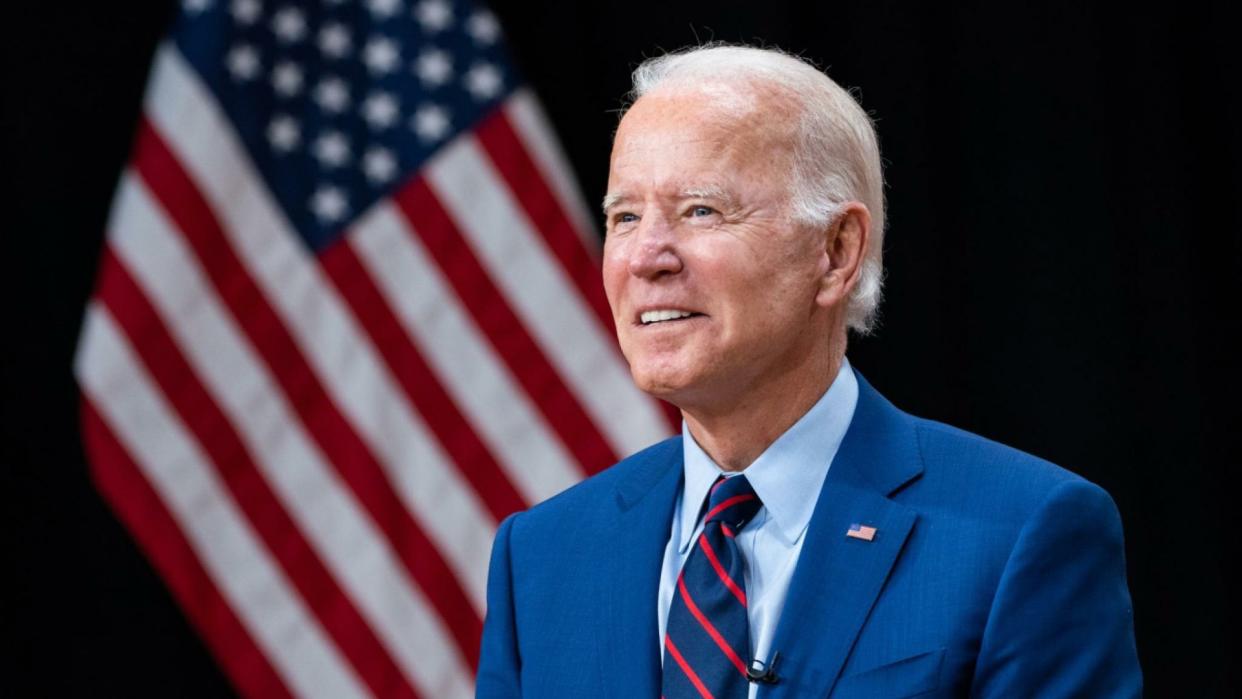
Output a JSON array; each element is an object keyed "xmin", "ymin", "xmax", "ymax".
[{"xmin": 133, "ymin": 119, "xmax": 483, "ymax": 668}]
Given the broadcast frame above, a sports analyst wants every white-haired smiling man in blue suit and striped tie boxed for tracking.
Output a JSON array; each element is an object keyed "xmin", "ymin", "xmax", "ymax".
[{"xmin": 478, "ymin": 46, "xmax": 1141, "ymax": 699}]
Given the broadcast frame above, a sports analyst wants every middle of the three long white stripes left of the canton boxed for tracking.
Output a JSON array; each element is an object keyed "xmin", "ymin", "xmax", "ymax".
[{"xmin": 111, "ymin": 174, "xmax": 473, "ymax": 697}]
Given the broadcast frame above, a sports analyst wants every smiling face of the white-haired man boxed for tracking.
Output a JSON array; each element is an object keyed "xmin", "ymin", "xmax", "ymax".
[{"xmin": 604, "ymin": 92, "xmax": 828, "ymax": 410}]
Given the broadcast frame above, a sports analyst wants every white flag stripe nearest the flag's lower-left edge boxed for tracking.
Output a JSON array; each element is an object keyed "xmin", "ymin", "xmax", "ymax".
[{"xmin": 76, "ymin": 309, "xmax": 368, "ymax": 698}]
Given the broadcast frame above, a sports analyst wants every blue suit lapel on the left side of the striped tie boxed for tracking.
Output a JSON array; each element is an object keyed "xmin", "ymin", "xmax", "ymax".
[{"xmin": 596, "ymin": 437, "xmax": 682, "ymax": 699}]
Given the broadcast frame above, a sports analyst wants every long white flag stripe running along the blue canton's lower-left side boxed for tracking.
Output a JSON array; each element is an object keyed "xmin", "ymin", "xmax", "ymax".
[{"xmin": 147, "ymin": 45, "xmax": 496, "ymax": 616}]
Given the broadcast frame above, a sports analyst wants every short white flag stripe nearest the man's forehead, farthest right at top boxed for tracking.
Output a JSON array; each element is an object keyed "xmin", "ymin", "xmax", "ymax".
[{"xmin": 504, "ymin": 88, "xmax": 600, "ymax": 252}]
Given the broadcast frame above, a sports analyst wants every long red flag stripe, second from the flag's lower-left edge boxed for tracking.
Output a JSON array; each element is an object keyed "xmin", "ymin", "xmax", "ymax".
[{"xmin": 97, "ymin": 252, "xmax": 415, "ymax": 697}]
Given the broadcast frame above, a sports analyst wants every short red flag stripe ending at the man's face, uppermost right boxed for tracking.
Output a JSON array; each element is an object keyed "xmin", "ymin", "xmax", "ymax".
[{"xmin": 474, "ymin": 108, "xmax": 612, "ymax": 334}]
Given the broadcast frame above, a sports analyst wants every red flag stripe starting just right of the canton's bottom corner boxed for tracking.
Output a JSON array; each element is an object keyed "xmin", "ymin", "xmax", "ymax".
[{"xmin": 319, "ymin": 238, "xmax": 527, "ymax": 521}]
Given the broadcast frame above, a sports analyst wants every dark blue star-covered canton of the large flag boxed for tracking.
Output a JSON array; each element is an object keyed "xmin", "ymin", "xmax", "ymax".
[{"xmin": 173, "ymin": 0, "xmax": 517, "ymax": 250}]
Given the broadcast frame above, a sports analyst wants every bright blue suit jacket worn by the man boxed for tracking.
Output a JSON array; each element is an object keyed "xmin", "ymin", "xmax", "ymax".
[{"xmin": 478, "ymin": 376, "xmax": 1141, "ymax": 699}]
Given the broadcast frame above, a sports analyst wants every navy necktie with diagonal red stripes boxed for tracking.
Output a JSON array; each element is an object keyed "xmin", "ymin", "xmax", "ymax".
[{"xmin": 663, "ymin": 476, "xmax": 763, "ymax": 699}]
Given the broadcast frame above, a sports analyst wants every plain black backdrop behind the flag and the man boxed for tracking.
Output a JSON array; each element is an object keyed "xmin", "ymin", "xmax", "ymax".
[{"xmin": 0, "ymin": 0, "xmax": 1242, "ymax": 697}]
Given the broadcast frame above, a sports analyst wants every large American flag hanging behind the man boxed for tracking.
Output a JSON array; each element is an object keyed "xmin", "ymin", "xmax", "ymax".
[{"xmin": 76, "ymin": 0, "xmax": 671, "ymax": 698}]
